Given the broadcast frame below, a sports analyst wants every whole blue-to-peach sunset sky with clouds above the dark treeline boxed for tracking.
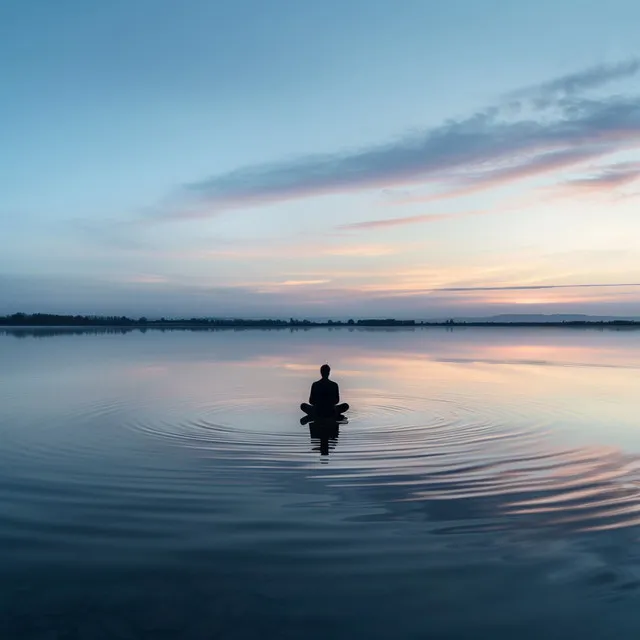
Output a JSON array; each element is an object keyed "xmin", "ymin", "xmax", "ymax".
[{"xmin": 0, "ymin": 0, "xmax": 640, "ymax": 319}]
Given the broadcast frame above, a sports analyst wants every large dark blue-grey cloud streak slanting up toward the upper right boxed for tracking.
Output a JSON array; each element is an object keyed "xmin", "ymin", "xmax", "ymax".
[{"xmin": 154, "ymin": 59, "xmax": 640, "ymax": 218}]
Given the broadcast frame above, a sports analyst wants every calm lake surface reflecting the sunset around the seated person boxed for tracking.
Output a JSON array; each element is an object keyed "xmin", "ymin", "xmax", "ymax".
[{"xmin": 0, "ymin": 327, "xmax": 640, "ymax": 640}]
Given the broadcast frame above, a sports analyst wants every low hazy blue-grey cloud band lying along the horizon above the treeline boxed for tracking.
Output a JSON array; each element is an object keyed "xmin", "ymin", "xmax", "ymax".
[{"xmin": 5, "ymin": 276, "xmax": 640, "ymax": 318}]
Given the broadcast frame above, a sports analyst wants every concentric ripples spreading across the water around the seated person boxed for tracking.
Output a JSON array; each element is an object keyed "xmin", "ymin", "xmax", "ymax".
[{"xmin": 75, "ymin": 384, "xmax": 640, "ymax": 530}]
